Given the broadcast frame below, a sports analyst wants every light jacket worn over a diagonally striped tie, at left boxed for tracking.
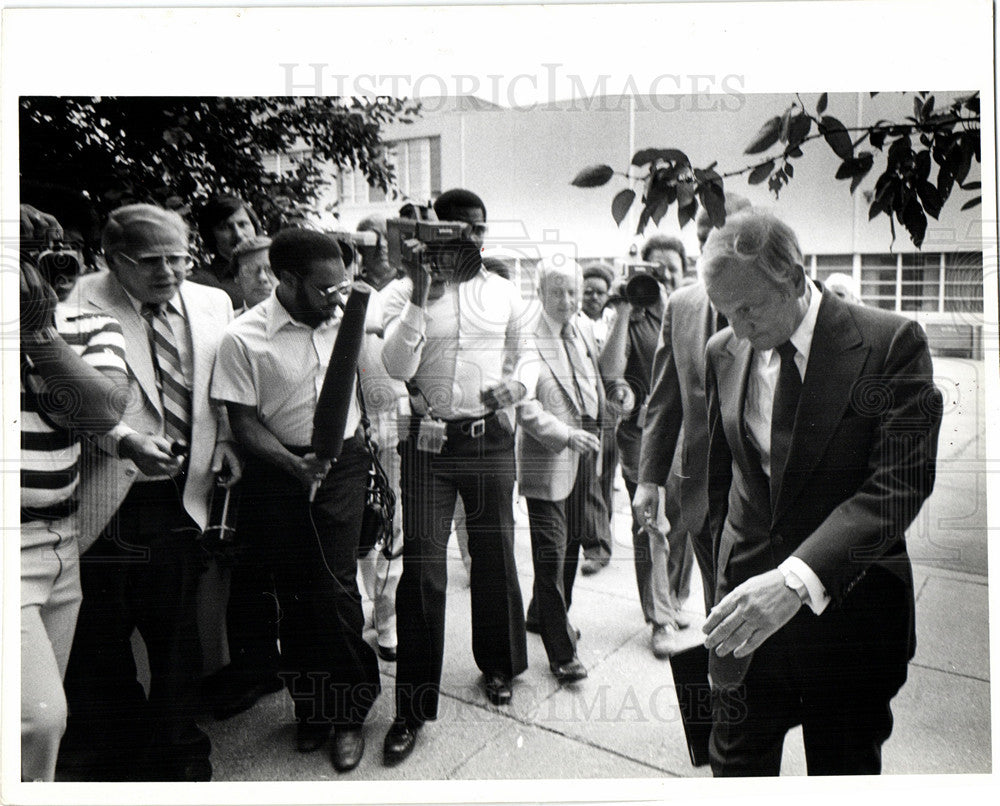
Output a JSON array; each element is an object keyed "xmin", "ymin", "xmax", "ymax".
[{"xmin": 72, "ymin": 272, "xmax": 233, "ymax": 551}]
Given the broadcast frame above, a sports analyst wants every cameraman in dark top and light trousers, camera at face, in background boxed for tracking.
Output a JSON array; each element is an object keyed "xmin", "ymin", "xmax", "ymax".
[{"xmin": 601, "ymin": 235, "xmax": 692, "ymax": 659}]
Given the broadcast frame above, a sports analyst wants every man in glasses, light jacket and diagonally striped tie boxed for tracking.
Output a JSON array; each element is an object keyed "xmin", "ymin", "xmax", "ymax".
[{"xmin": 66, "ymin": 204, "xmax": 240, "ymax": 781}]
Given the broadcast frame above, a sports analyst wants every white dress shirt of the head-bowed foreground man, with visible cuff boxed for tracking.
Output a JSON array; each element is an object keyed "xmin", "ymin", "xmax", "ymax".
[{"xmin": 743, "ymin": 280, "xmax": 830, "ymax": 615}]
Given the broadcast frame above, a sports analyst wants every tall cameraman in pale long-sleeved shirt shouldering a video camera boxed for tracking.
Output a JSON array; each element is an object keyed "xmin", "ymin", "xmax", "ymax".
[{"xmin": 382, "ymin": 189, "xmax": 527, "ymax": 766}]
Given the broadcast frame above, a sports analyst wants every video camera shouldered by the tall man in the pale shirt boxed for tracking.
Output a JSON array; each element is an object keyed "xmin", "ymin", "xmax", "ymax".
[{"xmin": 386, "ymin": 218, "xmax": 479, "ymax": 279}]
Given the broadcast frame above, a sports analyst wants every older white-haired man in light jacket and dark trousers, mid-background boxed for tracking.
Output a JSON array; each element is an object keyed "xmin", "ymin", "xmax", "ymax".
[{"xmin": 517, "ymin": 259, "xmax": 611, "ymax": 683}]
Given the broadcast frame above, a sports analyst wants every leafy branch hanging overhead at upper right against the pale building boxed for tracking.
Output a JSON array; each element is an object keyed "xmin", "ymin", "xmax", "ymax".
[{"xmin": 572, "ymin": 92, "xmax": 982, "ymax": 247}]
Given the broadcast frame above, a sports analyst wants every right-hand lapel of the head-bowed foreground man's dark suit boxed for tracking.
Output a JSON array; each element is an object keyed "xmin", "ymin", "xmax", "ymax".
[{"xmin": 774, "ymin": 292, "xmax": 869, "ymax": 522}]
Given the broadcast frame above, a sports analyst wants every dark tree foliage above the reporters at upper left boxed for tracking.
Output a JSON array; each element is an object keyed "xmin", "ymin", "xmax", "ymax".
[{"xmin": 20, "ymin": 96, "xmax": 419, "ymax": 234}]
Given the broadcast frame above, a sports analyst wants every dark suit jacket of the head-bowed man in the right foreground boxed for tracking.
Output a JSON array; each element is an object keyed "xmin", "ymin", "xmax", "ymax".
[{"xmin": 706, "ymin": 292, "xmax": 941, "ymax": 680}]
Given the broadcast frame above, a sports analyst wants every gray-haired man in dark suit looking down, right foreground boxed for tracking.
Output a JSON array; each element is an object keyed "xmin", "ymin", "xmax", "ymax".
[{"xmin": 702, "ymin": 211, "xmax": 941, "ymax": 775}]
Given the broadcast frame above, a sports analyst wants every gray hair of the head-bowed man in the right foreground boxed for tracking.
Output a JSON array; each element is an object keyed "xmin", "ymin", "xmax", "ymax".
[{"xmin": 701, "ymin": 208, "xmax": 803, "ymax": 288}]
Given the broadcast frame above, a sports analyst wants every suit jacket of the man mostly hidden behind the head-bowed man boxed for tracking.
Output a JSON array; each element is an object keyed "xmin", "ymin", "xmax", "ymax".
[{"xmin": 639, "ymin": 282, "xmax": 715, "ymax": 535}]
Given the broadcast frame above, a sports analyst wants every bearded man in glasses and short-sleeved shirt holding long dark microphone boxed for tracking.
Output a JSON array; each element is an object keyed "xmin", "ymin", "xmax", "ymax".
[{"xmin": 212, "ymin": 229, "xmax": 380, "ymax": 772}]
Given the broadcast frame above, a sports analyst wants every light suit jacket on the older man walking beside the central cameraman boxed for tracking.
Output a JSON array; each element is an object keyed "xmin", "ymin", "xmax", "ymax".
[{"xmin": 517, "ymin": 316, "xmax": 605, "ymax": 501}]
